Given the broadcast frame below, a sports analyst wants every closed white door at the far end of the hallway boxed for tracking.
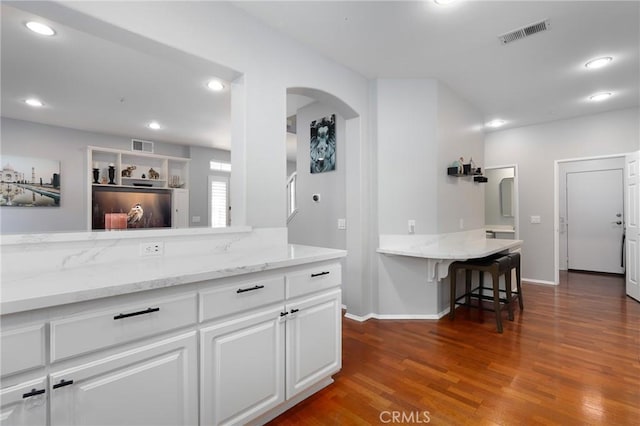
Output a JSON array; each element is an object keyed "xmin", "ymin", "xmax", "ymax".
[{"xmin": 567, "ymin": 169, "xmax": 624, "ymax": 274}]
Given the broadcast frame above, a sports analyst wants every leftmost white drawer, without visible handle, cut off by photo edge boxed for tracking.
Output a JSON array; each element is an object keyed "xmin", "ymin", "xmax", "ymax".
[{"xmin": 0, "ymin": 324, "xmax": 45, "ymax": 376}]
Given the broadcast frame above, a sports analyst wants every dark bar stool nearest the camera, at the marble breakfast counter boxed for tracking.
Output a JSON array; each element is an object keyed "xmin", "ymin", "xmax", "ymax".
[{"xmin": 449, "ymin": 256, "xmax": 513, "ymax": 333}]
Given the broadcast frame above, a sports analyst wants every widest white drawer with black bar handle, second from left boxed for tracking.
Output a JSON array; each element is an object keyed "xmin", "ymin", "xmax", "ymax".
[{"xmin": 51, "ymin": 293, "xmax": 198, "ymax": 362}]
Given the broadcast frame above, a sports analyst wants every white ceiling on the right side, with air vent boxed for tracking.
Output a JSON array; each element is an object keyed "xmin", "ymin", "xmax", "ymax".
[{"xmin": 236, "ymin": 0, "xmax": 640, "ymax": 129}]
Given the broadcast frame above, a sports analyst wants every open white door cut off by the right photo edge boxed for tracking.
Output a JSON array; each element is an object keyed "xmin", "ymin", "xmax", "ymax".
[{"xmin": 624, "ymin": 152, "xmax": 640, "ymax": 301}]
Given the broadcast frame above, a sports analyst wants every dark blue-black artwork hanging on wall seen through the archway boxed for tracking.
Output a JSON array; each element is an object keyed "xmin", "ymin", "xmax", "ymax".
[{"xmin": 309, "ymin": 114, "xmax": 336, "ymax": 173}]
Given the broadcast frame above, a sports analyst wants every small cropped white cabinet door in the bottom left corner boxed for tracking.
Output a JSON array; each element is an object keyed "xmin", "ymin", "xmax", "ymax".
[{"xmin": 0, "ymin": 377, "xmax": 47, "ymax": 426}]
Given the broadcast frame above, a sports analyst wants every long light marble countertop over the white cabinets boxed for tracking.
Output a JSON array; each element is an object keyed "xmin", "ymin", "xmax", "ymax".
[{"xmin": 0, "ymin": 244, "xmax": 347, "ymax": 315}]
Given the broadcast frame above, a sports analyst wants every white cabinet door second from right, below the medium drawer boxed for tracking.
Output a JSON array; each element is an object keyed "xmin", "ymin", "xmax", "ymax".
[{"xmin": 200, "ymin": 306, "xmax": 285, "ymax": 425}]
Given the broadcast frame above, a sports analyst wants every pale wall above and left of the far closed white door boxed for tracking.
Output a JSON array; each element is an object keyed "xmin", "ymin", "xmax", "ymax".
[{"xmin": 485, "ymin": 108, "xmax": 640, "ymax": 283}]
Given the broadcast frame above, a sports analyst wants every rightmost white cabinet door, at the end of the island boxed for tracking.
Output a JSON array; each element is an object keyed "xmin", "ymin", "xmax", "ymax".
[{"xmin": 286, "ymin": 289, "xmax": 342, "ymax": 399}]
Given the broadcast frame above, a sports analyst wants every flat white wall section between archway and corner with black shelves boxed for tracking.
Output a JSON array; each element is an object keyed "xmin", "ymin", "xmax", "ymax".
[{"xmin": 375, "ymin": 79, "xmax": 438, "ymax": 234}]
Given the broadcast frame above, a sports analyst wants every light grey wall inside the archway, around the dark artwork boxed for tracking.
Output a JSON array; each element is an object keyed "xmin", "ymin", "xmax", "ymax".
[{"xmin": 288, "ymin": 102, "xmax": 349, "ymax": 249}]
